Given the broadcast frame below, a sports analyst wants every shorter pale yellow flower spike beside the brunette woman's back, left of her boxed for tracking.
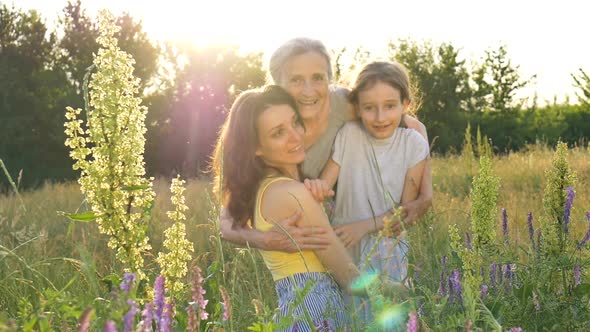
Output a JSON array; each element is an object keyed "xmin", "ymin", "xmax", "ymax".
[{"xmin": 157, "ymin": 177, "xmax": 194, "ymax": 300}]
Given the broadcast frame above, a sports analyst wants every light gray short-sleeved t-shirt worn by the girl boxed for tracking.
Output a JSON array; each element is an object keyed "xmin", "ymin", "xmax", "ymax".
[{"xmin": 331, "ymin": 121, "xmax": 429, "ymax": 264}]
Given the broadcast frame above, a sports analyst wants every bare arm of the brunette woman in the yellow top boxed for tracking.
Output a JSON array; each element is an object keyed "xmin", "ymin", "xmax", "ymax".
[{"xmin": 261, "ymin": 181, "xmax": 359, "ymax": 292}]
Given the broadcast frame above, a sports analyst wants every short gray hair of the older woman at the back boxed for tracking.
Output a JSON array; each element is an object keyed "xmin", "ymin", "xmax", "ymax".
[{"xmin": 269, "ymin": 37, "xmax": 332, "ymax": 85}]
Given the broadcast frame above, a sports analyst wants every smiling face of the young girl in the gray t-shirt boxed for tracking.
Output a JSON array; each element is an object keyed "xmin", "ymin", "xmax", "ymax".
[{"xmin": 356, "ymin": 81, "xmax": 409, "ymax": 139}]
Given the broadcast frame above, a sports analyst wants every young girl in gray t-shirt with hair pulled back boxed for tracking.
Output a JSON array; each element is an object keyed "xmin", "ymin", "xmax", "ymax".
[{"xmin": 321, "ymin": 62, "xmax": 429, "ymax": 320}]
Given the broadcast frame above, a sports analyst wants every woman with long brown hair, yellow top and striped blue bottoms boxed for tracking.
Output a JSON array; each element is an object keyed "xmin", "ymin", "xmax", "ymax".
[{"xmin": 213, "ymin": 86, "xmax": 359, "ymax": 331}]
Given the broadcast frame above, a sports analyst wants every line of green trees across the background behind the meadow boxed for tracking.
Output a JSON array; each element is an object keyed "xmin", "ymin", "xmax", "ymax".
[{"xmin": 0, "ymin": 0, "xmax": 590, "ymax": 189}]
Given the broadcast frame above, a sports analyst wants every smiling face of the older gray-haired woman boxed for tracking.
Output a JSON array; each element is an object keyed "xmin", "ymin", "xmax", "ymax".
[{"xmin": 280, "ymin": 52, "xmax": 329, "ymax": 119}]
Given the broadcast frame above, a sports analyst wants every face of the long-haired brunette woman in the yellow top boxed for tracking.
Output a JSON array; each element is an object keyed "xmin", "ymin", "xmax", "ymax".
[{"xmin": 256, "ymin": 105, "xmax": 305, "ymax": 176}]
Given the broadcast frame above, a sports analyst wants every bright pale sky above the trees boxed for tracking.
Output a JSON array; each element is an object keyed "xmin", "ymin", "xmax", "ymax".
[{"xmin": 12, "ymin": 0, "xmax": 590, "ymax": 104}]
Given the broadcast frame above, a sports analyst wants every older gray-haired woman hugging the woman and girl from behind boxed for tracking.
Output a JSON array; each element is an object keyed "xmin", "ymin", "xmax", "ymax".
[{"xmin": 220, "ymin": 38, "xmax": 432, "ymax": 252}]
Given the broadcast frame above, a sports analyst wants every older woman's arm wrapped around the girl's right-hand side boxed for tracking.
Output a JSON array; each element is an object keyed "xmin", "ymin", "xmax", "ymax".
[{"xmin": 402, "ymin": 114, "xmax": 432, "ymax": 223}]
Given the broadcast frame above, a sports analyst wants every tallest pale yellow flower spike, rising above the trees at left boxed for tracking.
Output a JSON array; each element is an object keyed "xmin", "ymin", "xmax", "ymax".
[{"xmin": 65, "ymin": 11, "xmax": 155, "ymax": 279}]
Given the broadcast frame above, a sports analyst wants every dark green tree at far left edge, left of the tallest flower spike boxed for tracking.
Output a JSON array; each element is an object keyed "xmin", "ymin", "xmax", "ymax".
[{"xmin": 0, "ymin": 5, "xmax": 73, "ymax": 185}]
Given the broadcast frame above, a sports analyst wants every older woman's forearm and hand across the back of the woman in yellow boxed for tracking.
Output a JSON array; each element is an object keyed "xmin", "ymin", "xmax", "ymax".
[{"xmin": 219, "ymin": 208, "xmax": 330, "ymax": 252}]
